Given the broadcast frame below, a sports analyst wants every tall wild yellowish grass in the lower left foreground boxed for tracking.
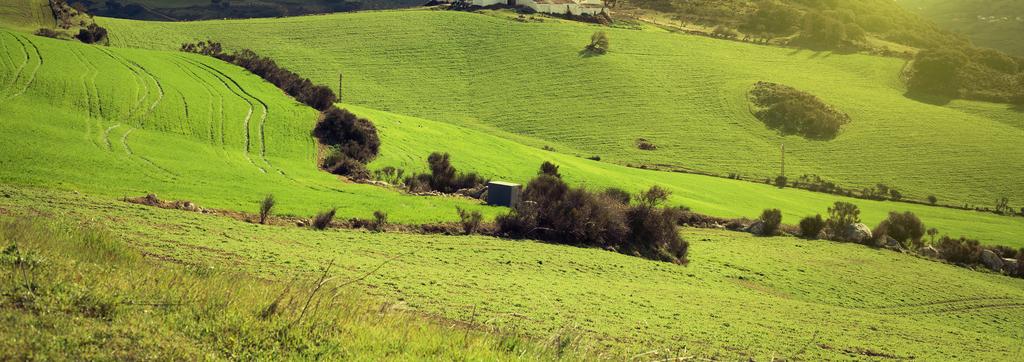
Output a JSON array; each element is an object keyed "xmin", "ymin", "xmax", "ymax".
[{"xmin": 0, "ymin": 219, "xmax": 593, "ymax": 360}]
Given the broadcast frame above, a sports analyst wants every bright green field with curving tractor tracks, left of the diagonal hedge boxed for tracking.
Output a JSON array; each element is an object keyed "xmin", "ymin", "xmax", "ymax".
[{"xmin": 0, "ymin": 31, "xmax": 498, "ymax": 223}]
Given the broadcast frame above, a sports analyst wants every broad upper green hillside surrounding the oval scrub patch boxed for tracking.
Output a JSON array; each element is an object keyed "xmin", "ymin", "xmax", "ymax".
[{"xmin": 100, "ymin": 11, "xmax": 1024, "ymax": 207}]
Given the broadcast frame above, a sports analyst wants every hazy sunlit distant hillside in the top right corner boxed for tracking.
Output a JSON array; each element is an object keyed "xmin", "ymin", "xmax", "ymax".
[{"xmin": 896, "ymin": 0, "xmax": 1024, "ymax": 56}]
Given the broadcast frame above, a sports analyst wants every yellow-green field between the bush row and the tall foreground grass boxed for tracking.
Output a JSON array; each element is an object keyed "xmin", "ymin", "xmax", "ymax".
[{"xmin": 8, "ymin": 186, "xmax": 1024, "ymax": 361}]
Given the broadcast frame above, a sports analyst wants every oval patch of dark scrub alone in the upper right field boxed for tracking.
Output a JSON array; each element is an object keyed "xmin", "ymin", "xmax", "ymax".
[{"xmin": 750, "ymin": 82, "xmax": 850, "ymax": 140}]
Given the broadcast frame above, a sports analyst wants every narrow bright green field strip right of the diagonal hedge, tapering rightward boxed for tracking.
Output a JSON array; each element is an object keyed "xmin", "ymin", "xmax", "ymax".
[{"xmin": 358, "ymin": 104, "xmax": 1024, "ymax": 247}]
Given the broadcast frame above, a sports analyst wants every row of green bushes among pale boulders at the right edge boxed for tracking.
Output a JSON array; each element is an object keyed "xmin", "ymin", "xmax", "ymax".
[{"xmin": 748, "ymin": 201, "xmax": 1024, "ymax": 277}]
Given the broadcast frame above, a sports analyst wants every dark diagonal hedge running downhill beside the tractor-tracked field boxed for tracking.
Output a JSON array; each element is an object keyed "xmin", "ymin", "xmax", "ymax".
[{"xmin": 181, "ymin": 40, "xmax": 380, "ymax": 179}]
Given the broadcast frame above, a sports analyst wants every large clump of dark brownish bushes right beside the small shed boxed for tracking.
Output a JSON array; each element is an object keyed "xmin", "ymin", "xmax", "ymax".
[{"xmin": 497, "ymin": 163, "xmax": 689, "ymax": 264}]
